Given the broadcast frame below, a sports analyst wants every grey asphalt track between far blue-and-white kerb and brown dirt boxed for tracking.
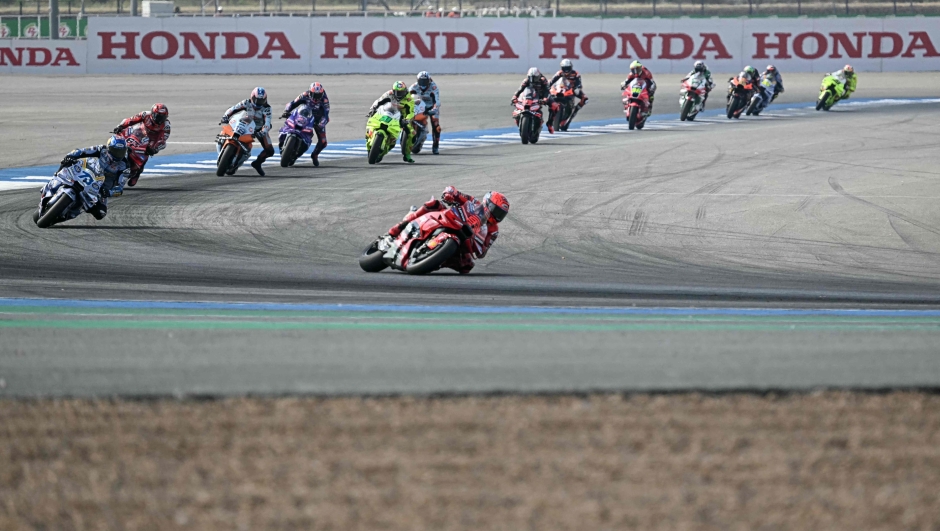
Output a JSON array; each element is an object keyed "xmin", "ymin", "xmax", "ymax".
[{"xmin": 0, "ymin": 74, "xmax": 940, "ymax": 396}]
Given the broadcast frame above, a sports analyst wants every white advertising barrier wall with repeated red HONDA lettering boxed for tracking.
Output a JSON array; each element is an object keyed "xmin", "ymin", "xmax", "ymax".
[{"xmin": 0, "ymin": 17, "xmax": 940, "ymax": 74}]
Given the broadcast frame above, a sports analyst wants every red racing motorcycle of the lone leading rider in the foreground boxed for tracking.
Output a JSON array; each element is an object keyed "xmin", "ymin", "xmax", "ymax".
[{"xmin": 359, "ymin": 208, "xmax": 473, "ymax": 275}]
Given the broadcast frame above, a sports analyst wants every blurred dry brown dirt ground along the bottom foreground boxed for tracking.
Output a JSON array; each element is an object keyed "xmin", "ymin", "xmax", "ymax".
[{"xmin": 0, "ymin": 392, "xmax": 940, "ymax": 531}]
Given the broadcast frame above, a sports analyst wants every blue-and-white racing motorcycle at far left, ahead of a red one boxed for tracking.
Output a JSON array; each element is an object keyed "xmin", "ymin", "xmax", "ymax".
[{"xmin": 33, "ymin": 159, "xmax": 118, "ymax": 229}]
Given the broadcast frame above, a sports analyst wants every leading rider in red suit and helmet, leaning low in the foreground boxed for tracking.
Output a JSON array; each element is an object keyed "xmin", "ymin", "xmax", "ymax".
[{"xmin": 388, "ymin": 186, "xmax": 509, "ymax": 275}]
